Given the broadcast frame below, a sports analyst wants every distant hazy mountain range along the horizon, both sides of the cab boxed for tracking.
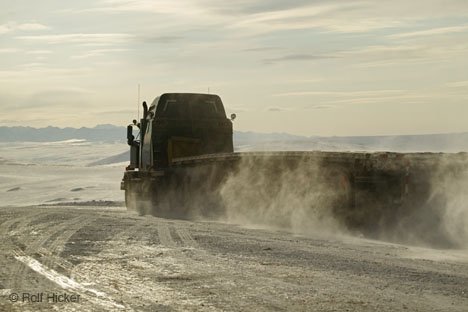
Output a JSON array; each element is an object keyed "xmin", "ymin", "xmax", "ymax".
[{"xmin": 0, "ymin": 125, "xmax": 468, "ymax": 152}]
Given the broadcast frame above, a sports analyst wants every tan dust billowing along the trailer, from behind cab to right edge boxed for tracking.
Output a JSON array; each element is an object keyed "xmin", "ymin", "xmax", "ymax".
[{"xmin": 219, "ymin": 154, "xmax": 468, "ymax": 249}]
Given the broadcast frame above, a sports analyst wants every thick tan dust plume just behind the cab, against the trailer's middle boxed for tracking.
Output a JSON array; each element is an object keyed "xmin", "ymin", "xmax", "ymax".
[{"xmin": 220, "ymin": 157, "xmax": 345, "ymax": 236}]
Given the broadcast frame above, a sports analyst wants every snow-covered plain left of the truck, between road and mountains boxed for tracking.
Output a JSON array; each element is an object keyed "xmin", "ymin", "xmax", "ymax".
[{"xmin": 0, "ymin": 140, "xmax": 127, "ymax": 206}]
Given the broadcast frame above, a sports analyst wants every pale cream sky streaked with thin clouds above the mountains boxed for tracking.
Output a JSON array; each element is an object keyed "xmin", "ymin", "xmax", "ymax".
[{"xmin": 0, "ymin": 0, "xmax": 468, "ymax": 136}]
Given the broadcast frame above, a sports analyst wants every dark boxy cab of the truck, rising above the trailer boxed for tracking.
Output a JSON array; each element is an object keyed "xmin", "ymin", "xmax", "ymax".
[{"xmin": 139, "ymin": 93, "xmax": 233, "ymax": 171}]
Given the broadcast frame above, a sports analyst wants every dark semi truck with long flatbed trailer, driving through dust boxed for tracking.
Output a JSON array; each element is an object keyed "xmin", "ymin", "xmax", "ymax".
[{"xmin": 121, "ymin": 93, "xmax": 468, "ymax": 239}]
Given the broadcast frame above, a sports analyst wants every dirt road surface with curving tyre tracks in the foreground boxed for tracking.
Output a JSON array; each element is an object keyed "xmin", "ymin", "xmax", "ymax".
[{"xmin": 0, "ymin": 206, "xmax": 468, "ymax": 311}]
